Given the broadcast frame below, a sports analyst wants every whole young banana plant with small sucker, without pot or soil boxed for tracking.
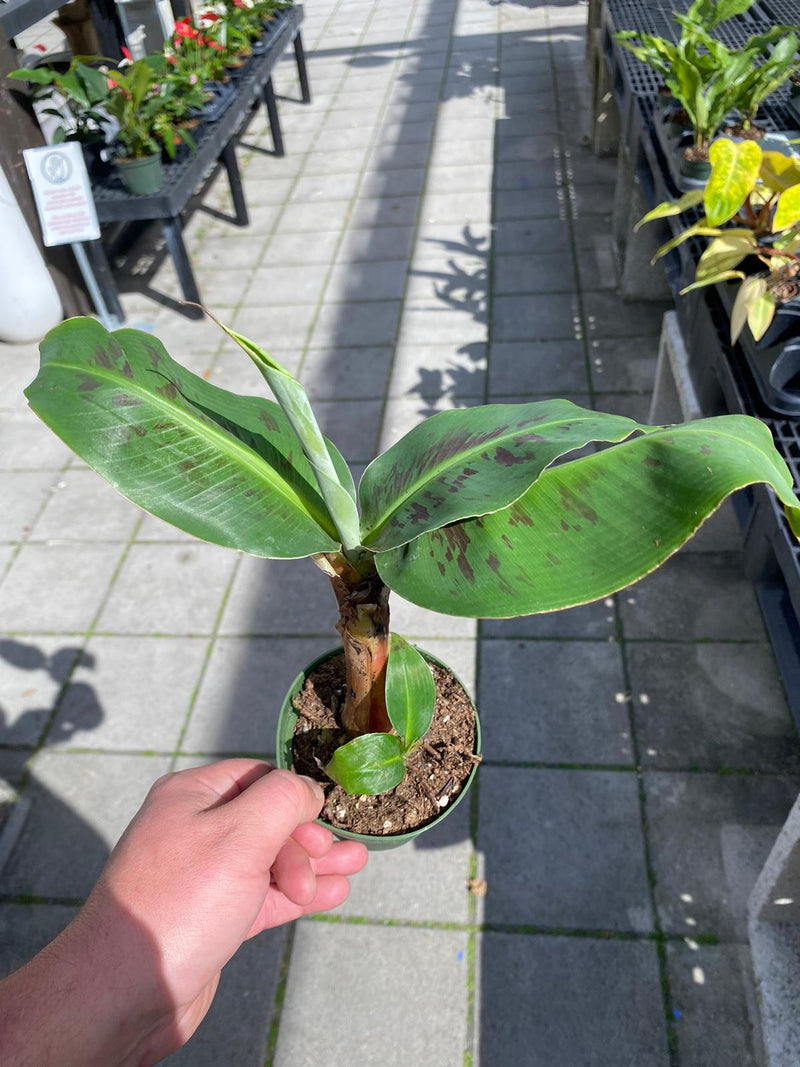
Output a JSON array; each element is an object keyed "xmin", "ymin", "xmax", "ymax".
[{"xmin": 26, "ymin": 311, "xmax": 800, "ymax": 793}]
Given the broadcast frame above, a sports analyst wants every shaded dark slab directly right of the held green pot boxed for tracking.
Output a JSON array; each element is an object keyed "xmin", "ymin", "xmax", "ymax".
[{"xmin": 478, "ymin": 640, "xmax": 633, "ymax": 764}]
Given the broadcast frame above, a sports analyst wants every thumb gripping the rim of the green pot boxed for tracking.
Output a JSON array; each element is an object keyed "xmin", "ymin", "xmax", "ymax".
[{"xmin": 218, "ymin": 770, "xmax": 325, "ymax": 863}]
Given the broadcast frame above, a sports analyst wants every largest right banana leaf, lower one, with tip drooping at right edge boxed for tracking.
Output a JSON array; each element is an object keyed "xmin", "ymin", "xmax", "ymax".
[{"xmin": 375, "ymin": 415, "xmax": 800, "ymax": 618}]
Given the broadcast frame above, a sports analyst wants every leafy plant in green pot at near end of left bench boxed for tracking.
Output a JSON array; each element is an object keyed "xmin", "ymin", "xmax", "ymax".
[{"xmin": 106, "ymin": 55, "xmax": 188, "ymax": 195}]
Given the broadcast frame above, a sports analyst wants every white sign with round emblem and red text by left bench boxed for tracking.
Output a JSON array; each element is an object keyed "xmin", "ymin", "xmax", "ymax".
[{"xmin": 22, "ymin": 141, "xmax": 100, "ymax": 246}]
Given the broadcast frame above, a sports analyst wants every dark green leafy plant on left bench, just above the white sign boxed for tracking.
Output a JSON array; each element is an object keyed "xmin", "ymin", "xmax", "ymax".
[{"xmin": 9, "ymin": 55, "xmax": 109, "ymax": 144}]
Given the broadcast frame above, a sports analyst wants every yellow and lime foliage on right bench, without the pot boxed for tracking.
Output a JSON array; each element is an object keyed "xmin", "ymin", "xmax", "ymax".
[{"xmin": 635, "ymin": 138, "xmax": 800, "ymax": 341}]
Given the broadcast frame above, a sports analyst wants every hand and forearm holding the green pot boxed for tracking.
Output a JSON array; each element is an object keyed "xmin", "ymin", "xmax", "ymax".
[{"xmin": 0, "ymin": 760, "xmax": 367, "ymax": 1067}]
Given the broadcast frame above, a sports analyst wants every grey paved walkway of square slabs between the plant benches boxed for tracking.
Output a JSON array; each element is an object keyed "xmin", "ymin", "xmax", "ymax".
[{"xmin": 0, "ymin": 0, "xmax": 800, "ymax": 1067}]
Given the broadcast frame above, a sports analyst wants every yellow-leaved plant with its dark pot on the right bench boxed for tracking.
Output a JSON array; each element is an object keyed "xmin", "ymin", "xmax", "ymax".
[{"xmin": 637, "ymin": 138, "xmax": 800, "ymax": 414}]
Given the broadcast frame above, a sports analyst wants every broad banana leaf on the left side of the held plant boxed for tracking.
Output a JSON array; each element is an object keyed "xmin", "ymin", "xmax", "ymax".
[{"xmin": 26, "ymin": 319, "xmax": 349, "ymax": 558}]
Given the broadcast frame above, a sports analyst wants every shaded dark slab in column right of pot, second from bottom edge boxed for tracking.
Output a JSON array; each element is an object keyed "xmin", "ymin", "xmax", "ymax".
[{"xmin": 477, "ymin": 768, "xmax": 653, "ymax": 933}]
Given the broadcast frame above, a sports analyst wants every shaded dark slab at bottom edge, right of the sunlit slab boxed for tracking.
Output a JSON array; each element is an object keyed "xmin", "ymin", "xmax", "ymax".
[{"xmin": 475, "ymin": 934, "xmax": 670, "ymax": 1067}]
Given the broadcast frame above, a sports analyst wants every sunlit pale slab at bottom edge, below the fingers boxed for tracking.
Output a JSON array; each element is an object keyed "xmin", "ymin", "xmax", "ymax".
[{"xmin": 274, "ymin": 921, "xmax": 467, "ymax": 1067}]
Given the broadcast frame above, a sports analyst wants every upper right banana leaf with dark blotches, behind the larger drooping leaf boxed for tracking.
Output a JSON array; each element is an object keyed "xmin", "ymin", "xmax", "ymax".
[{"xmin": 358, "ymin": 400, "xmax": 638, "ymax": 551}]
